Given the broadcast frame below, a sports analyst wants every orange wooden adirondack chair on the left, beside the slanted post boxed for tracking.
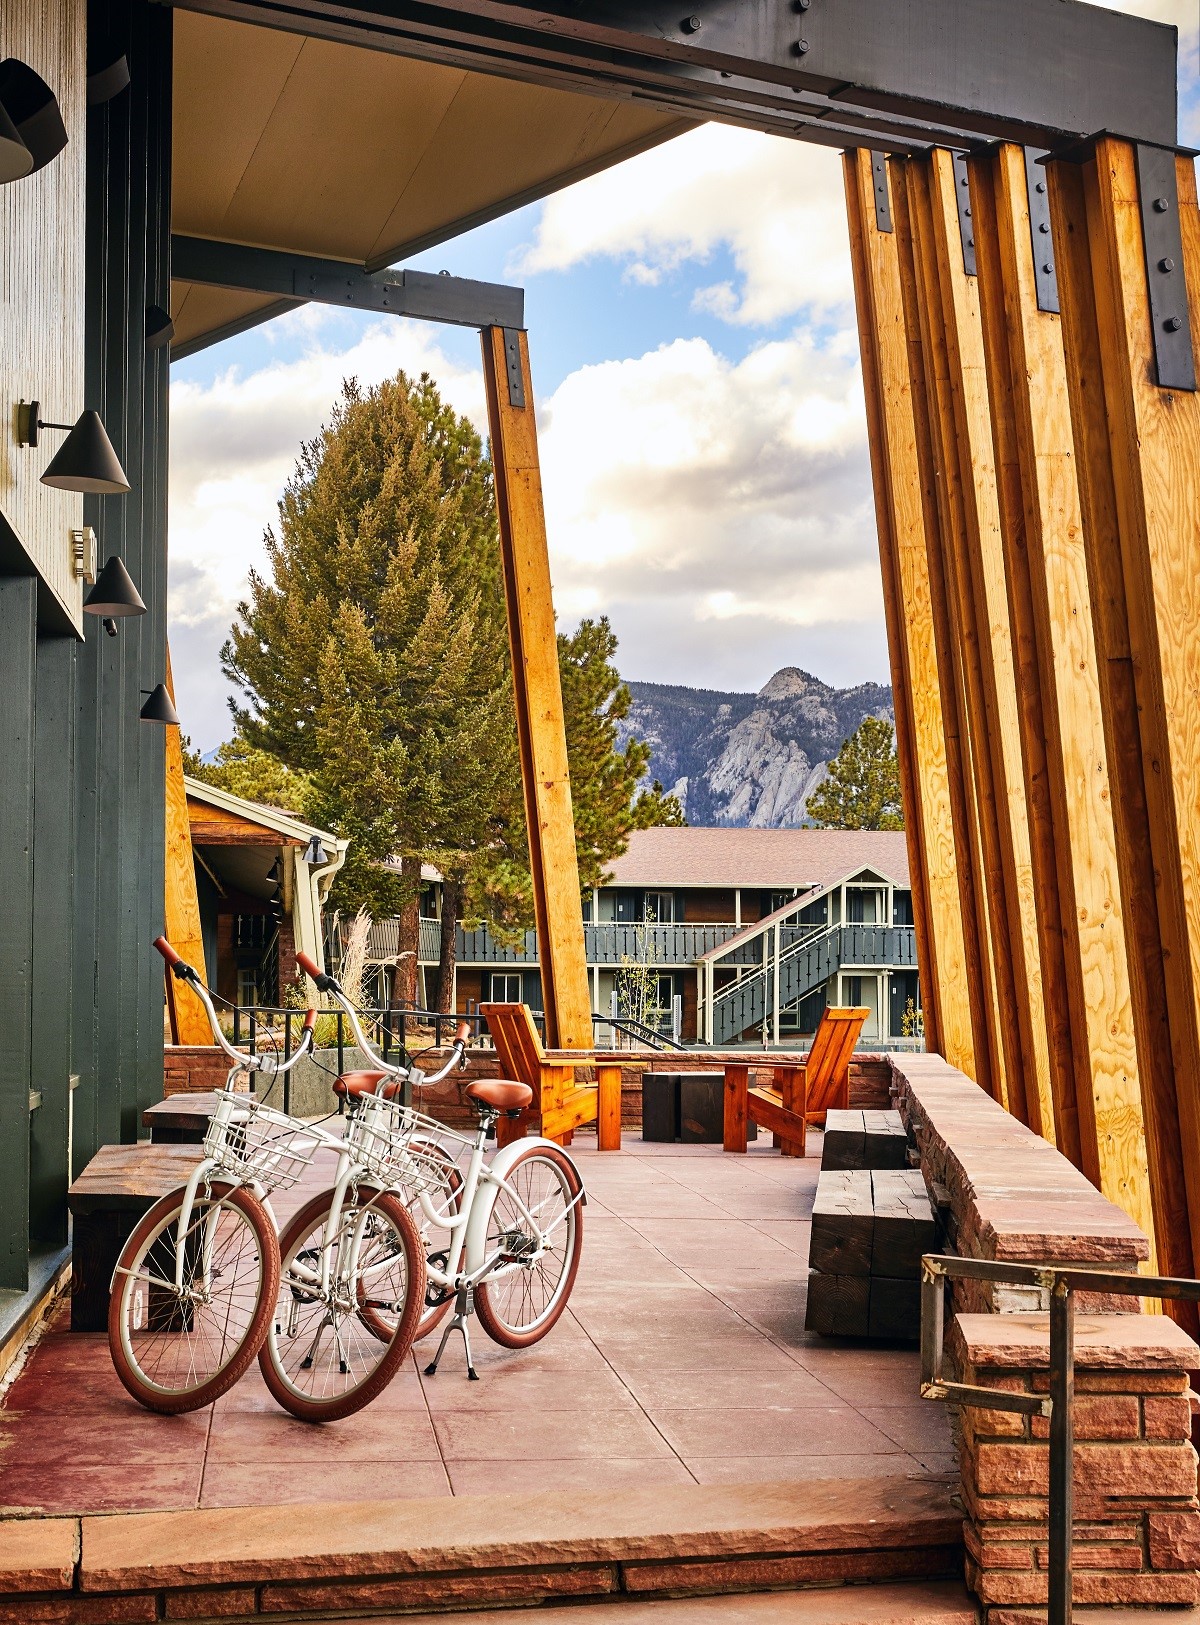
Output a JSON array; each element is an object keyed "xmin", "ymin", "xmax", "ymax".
[{"xmin": 480, "ymin": 1004, "xmax": 621, "ymax": 1151}]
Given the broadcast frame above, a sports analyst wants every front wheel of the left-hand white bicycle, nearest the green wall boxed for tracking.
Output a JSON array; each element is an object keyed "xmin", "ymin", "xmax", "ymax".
[{"xmin": 109, "ymin": 1183, "xmax": 280, "ymax": 1415}]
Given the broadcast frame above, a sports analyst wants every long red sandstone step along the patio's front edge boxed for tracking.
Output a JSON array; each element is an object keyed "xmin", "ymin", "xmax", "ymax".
[{"xmin": 0, "ymin": 1464, "xmax": 963, "ymax": 1625}]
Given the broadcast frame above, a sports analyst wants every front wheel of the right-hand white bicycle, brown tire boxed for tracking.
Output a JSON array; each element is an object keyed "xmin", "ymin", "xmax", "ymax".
[{"xmin": 259, "ymin": 1186, "xmax": 426, "ymax": 1422}]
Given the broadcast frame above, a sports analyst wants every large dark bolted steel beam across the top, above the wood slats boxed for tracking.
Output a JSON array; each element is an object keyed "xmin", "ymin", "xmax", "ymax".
[{"xmin": 171, "ymin": 0, "xmax": 1177, "ymax": 146}]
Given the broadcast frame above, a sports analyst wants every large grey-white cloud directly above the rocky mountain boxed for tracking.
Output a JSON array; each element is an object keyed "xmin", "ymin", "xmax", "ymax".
[{"xmin": 541, "ymin": 336, "xmax": 885, "ymax": 687}]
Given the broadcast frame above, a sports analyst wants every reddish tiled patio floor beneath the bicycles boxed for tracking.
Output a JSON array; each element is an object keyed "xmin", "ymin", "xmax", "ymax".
[{"xmin": 0, "ymin": 1134, "xmax": 954, "ymax": 1513}]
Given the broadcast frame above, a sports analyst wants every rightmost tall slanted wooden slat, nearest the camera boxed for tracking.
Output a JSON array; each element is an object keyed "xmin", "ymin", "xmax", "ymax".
[{"xmin": 1047, "ymin": 137, "xmax": 1200, "ymax": 1272}]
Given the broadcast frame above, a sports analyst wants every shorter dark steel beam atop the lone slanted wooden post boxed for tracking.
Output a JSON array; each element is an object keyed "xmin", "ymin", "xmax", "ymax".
[{"xmin": 171, "ymin": 236, "xmax": 525, "ymax": 328}]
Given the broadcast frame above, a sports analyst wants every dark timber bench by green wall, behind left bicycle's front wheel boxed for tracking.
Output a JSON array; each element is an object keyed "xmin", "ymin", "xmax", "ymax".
[{"xmin": 67, "ymin": 1141, "xmax": 203, "ymax": 1331}]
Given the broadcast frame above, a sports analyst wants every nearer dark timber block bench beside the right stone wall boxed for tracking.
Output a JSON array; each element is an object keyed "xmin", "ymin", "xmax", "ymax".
[{"xmin": 805, "ymin": 1168, "xmax": 937, "ymax": 1342}]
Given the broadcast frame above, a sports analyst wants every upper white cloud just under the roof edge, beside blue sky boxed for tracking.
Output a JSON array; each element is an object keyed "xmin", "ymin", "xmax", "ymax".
[{"xmin": 514, "ymin": 124, "xmax": 850, "ymax": 325}]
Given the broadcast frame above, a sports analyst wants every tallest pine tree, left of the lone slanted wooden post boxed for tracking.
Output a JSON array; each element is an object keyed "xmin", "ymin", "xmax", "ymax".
[{"xmin": 221, "ymin": 374, "xmax": 517, "ymax": 1001}]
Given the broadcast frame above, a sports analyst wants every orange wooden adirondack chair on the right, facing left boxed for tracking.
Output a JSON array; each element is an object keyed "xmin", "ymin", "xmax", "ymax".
[{"xmin": 725, "ymin": 1006, "xmax": 870, "ymax": 1157}]
